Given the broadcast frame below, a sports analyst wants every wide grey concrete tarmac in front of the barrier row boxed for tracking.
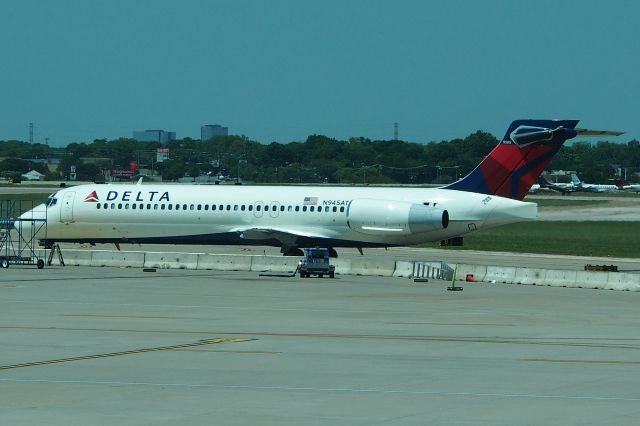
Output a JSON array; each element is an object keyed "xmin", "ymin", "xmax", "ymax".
[{"xmin": 0, "ymin": 266, "xmax": 640, "ymax": 425}]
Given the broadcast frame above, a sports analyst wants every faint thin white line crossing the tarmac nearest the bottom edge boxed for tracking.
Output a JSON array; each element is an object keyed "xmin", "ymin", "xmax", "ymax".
[{"xmin": 0, "ymin": 378, "xmax": 640, "ymax": 403}]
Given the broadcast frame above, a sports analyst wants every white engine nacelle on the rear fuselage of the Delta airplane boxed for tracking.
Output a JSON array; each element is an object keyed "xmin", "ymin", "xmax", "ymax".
[{"xmin": 347, "ymin": 199, "xmax": 449, "ymax": 235}]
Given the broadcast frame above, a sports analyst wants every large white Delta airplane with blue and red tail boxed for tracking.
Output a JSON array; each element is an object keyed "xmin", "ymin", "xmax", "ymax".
[{"xmin": 19, "ymin": 120, "xmax": 620, "ymax": 256}]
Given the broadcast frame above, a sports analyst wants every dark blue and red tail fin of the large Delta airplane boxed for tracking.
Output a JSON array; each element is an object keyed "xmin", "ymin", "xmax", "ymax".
[{"xmin": 444, "ymin": 120, "xmax": 580, "ymax": 200}]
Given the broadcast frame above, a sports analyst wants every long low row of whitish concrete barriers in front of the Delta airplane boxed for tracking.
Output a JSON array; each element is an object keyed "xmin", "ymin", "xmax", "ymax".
[{"xmin": 38, "ymin": 249, "xmax": 640, "ymax": 291}]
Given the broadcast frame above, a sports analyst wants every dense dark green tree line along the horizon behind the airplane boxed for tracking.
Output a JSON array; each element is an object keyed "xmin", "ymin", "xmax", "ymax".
[{"xmin": 0, "ymin": 131, "xmax": 640, "ymax": 184}]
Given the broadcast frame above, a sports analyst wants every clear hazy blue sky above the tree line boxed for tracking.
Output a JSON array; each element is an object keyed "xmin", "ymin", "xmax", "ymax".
[{"xmin": 0, "ymin": 0, "xmax": 640, "ymax": 146}]
